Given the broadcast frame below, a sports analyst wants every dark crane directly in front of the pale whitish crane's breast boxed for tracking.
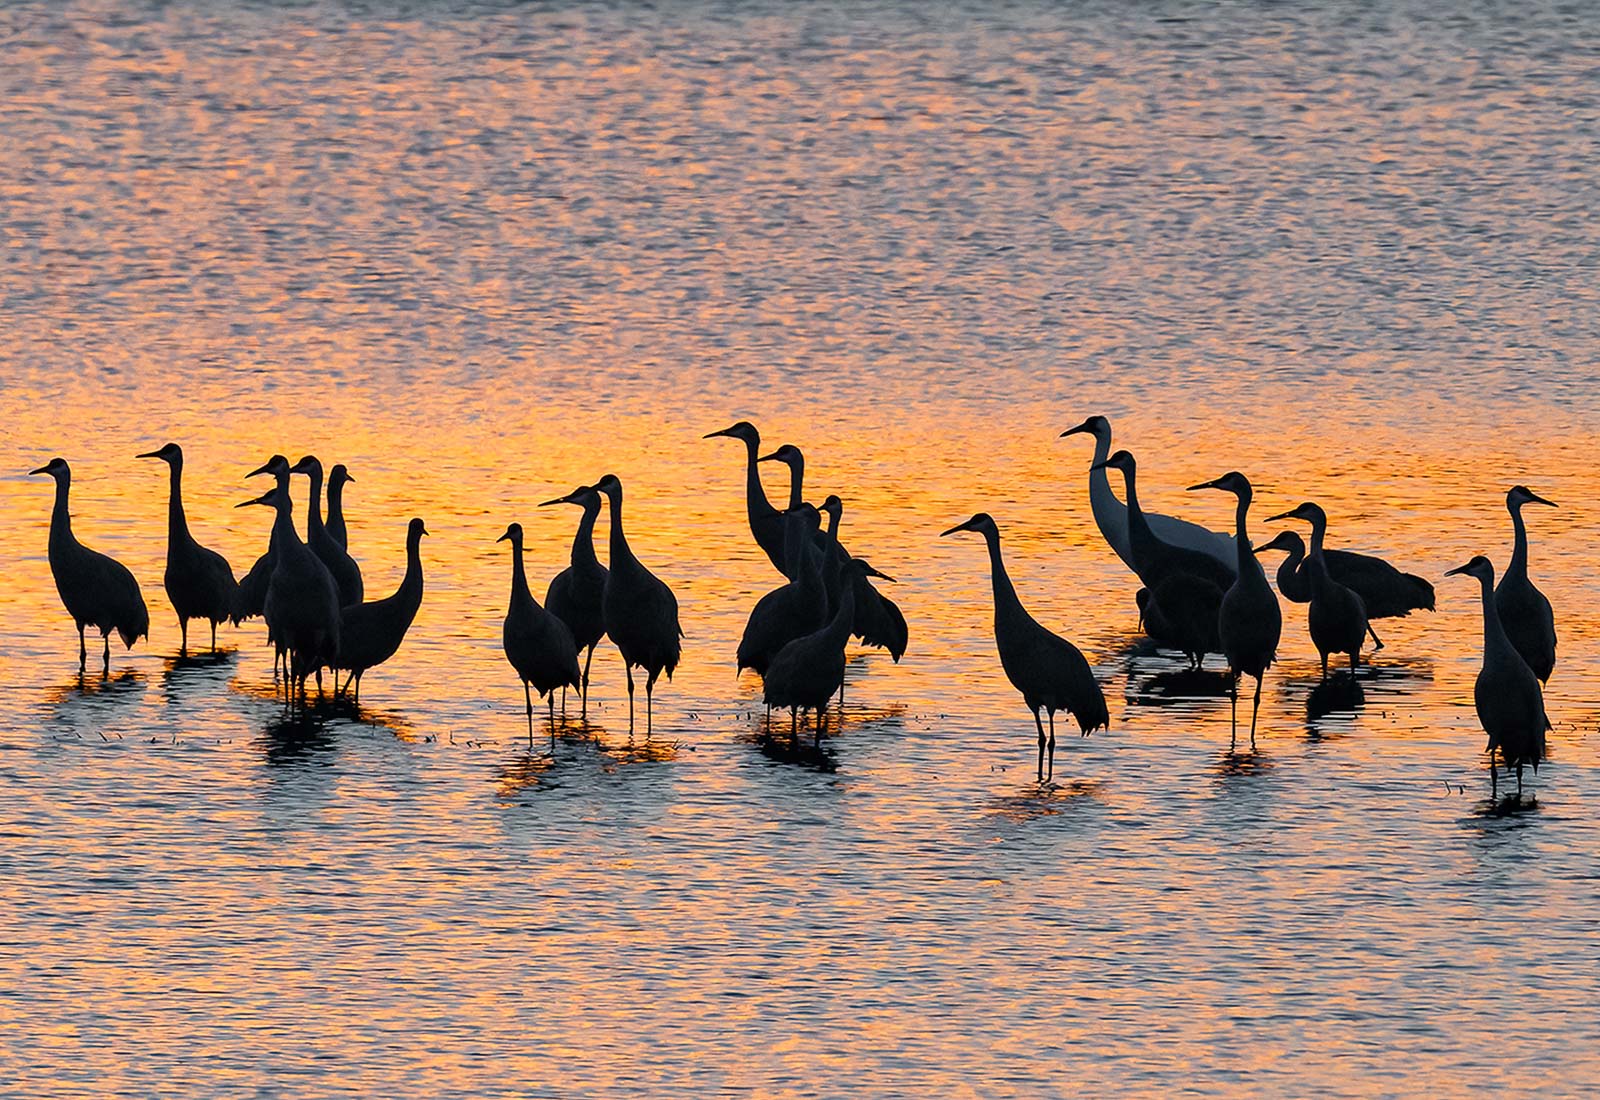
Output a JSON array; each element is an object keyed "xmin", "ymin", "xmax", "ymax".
[{"xmin": 1099, "ymin": 451, "xmax": 1237, "ymax": 668}]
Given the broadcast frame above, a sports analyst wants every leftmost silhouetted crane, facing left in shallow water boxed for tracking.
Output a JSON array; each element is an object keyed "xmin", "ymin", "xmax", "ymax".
[{"xmin": 29, "ymin": 459, "xmax": 150, "ymax": 676}]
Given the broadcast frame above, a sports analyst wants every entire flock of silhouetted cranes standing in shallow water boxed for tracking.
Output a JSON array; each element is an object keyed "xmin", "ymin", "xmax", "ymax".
[{"xmin": 21, "ymin": 416, "xmax": 1555, "ymax": 793}]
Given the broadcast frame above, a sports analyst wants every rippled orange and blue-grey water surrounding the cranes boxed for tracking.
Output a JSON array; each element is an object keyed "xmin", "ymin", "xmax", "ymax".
[{"xmin": 0, "ymin": 2, "xmax": 1600, "ymax": 1097}]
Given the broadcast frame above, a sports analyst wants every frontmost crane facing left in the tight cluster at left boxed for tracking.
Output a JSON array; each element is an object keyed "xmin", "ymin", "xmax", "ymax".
[{"xmin": 238, "ymin": 486, "xmax": 339, "ymax": 702}]
